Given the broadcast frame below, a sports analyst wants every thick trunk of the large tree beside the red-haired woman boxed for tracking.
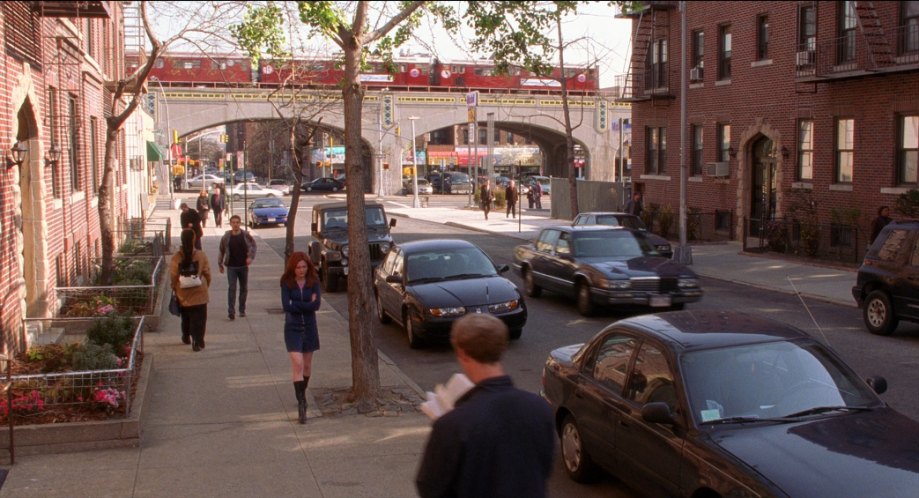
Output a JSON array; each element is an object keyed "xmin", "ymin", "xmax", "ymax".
[{"xmin": 342, "ymin": 38, "xmax": 380, "ymax": 412}]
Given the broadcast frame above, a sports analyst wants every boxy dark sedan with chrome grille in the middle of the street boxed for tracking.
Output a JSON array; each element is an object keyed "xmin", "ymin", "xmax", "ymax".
[{"xmin": 514, "ymin": 225, "xmax": 702, "ymax": 316}]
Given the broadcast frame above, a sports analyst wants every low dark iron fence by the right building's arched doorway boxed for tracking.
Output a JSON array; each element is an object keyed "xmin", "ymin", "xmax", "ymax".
[{"xmin": 743, "ymin": 218, "xmax": 868, "ymax": 265}]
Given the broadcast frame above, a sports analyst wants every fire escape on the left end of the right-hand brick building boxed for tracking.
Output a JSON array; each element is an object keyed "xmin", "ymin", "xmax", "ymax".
[{"xmin": 616, "ymin": 1, "xmax": 679, "ymax": 102}]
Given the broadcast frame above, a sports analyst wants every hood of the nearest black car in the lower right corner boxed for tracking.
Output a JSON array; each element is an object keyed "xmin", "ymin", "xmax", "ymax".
[{"xmin": 713, "ymin": 407, "xmax": 919, "ymax": 497}]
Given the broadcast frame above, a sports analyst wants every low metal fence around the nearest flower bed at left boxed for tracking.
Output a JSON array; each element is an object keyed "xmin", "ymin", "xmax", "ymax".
[{"xmin": 0, "ymin": 317, "xmax": 144, "ymax": 419}]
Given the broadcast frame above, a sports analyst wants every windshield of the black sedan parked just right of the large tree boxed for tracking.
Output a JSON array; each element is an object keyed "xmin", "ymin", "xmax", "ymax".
[{"xmin": 406, "ymin": 247, "xmax": 497, "ymax": 283}]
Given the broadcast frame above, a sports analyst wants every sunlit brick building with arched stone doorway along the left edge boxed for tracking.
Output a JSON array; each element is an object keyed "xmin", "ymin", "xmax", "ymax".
[{"xmin": 0, "ymin": 1, "xmax": 127, "ymax": 351}]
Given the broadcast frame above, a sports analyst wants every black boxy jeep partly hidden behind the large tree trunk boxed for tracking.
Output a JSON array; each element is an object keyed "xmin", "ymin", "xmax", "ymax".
[{"xmin": 309, "ymin": 202, "xmax": 396, "ymax": 292}]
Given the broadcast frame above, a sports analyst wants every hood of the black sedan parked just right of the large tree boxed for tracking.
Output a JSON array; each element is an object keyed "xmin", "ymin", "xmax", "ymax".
[{"xmin": 408, "ymin": 276, "xmax": 520, "ymax": 308}]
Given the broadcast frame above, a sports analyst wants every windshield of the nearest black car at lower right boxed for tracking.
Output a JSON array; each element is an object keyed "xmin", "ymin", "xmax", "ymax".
[{"xmin": 680, "ymin": 341, "xmax": 880, "ymax": 424}]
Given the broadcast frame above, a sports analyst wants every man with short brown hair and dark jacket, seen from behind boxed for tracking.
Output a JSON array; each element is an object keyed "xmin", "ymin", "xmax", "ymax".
[{"xmin": 415, "ymin": 313, "xmax": 555, "ymax": 498}]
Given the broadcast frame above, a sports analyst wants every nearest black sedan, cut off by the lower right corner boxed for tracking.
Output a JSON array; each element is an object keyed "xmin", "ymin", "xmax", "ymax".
[{"xmin": 541, "ymin": 310, "xmax": 919, "ymax": 497}]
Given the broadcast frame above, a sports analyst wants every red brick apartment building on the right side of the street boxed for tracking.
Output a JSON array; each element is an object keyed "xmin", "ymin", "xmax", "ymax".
[{"xmin": 619, "ymin": 1, "xmax": 919, "ymax": 250}]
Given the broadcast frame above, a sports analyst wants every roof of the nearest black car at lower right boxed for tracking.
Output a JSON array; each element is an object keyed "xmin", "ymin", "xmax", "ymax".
[{"xmin": 604, "ymin": 310, "xmax": 810, "ymax": 351}]
